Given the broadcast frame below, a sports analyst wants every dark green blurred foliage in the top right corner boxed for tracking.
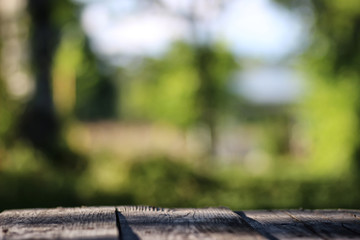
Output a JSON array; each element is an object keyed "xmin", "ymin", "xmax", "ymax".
[{"xmin": 314, "ymin": 1, "xmax": 360, "ymax": 74}]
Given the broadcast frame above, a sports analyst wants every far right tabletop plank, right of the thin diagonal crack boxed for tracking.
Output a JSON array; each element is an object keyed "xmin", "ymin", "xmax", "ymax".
[{"xmin": 286, "ymin": 210, "xmax": 360, "ymax": 239}]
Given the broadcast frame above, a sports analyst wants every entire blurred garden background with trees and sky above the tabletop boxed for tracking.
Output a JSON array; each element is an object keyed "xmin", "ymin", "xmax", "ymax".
[{"xmin": 0, "ymin": 0, "xmax": 360, "ymax": 210}]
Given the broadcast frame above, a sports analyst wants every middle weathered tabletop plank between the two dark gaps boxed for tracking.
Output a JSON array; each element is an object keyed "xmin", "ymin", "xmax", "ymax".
[{"xmin": 117, "ymin": 206, "xmax": 265, "ymax": 240}]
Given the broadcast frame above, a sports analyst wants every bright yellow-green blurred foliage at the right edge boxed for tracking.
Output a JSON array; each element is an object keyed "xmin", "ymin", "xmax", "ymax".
[{"xmin": 301, "ymin": 72, "xmax": 358, "ymax": 175}]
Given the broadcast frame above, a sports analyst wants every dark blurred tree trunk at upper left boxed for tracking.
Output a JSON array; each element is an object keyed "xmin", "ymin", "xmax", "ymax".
[{"xmin": 21, "ymin": 0, "xmax": 59, "ymax": 158}]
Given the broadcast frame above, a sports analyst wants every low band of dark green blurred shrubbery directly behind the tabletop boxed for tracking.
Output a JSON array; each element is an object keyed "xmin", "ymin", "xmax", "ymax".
[{"xmin": 0, "ymin": 153, "xmax": 360, "ymax": 210}]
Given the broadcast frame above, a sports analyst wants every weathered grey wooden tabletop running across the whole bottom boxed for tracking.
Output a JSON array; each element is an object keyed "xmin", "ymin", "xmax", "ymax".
[{"xmin": 0, "ymin": 206, "xmax": 360, "ymax": 240}]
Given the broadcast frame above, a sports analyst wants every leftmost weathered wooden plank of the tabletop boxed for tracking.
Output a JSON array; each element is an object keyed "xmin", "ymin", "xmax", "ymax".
[{"xmin": 0, "ymin": 207, "xmax": 118, "ymax": 240}]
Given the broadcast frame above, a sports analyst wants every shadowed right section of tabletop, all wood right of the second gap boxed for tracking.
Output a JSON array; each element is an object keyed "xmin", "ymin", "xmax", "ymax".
[{"xmin": 237, "ymin": 210, "xmax": 360, "ymax": 239}]
